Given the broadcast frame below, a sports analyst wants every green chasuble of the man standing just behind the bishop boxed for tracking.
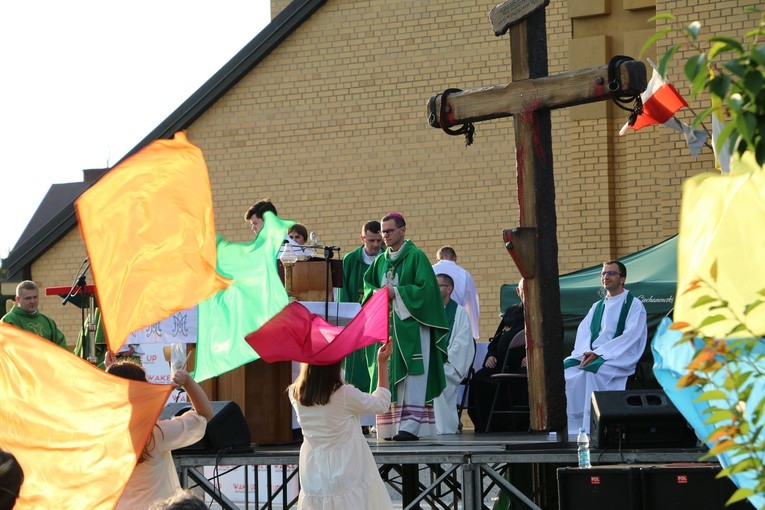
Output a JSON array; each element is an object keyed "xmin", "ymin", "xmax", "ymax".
[{"xmin": 339, "ymin": 245, "xmax": 379, "ymax": 393}]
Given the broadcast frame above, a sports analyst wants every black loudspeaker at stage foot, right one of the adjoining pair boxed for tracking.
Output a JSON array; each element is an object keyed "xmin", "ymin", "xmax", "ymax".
[{"xmin": 640, "ymin": 464, "xmax": 753, "ymax": 510}]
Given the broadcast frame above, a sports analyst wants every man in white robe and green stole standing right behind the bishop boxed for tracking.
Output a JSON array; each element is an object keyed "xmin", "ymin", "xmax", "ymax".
[{"xmin": 433, "ymin": 274, "xmax": 475, "ymax": 434}]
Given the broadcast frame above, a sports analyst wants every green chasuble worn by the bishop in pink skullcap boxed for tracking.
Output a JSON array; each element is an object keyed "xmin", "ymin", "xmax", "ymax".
[{"xmin": 364, "ymin": 240, "xmax": 449, "ymax": 402}]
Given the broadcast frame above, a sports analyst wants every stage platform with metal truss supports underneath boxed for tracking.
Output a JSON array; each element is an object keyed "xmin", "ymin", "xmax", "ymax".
[{"xmin": 174, "ymin": 432, "xmax": 704, "ymax": 510}]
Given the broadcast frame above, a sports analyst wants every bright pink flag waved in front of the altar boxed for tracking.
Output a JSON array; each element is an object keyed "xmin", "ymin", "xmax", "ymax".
[{"xmin": 246, "ymin": 292, "xmax": 388, "ymax": 365}]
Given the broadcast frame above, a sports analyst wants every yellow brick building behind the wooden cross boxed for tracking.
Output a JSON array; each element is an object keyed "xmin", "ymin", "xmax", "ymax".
[{"xmin": 4, "ymin": 0, "xmax": 760, "ymax": 344}]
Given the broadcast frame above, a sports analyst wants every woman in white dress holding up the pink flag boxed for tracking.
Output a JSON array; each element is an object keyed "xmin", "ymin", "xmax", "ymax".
[{"xmin": 287, "ymin": 342, "xmax": 393, "ymax": 510}]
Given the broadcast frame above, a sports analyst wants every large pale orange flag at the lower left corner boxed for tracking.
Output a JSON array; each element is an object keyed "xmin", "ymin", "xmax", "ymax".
[{"xmin": 0, "ymin": 323, "xmax": 171, "ymax": 509}]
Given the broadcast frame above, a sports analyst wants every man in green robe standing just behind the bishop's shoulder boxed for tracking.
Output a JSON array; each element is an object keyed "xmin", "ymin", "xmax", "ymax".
[{"xmin": 340, "ymin": 220, "xmax": 382, "ymax": 393}]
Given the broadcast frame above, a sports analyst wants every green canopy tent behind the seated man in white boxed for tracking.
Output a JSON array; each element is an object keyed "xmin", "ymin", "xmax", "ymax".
[{"xmin": 499, "ymin": 236, "xmax": 677, "ymax": 388}]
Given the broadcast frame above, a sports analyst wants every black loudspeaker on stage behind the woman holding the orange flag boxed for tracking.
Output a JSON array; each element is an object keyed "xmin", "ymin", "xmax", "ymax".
[{"xmin": 159, "ymin": 400, "xmax": 251, "ymax": 453}]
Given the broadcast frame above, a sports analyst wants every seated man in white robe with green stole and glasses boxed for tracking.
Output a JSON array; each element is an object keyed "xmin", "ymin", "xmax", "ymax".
[{"xmin": 563, "ymin": 260, "xmax": 648, "ymax": 435}]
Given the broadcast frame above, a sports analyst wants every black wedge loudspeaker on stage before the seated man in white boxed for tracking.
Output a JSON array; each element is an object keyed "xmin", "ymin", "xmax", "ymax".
[{"xmin": 590, "ymin": 390, "xmax": 696, "ymax": 448}]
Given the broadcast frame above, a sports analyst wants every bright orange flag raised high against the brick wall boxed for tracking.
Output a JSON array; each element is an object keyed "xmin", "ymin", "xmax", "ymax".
[{"xmin": 75, "ymin": 132, "xmax": 228, "ymax": 352}]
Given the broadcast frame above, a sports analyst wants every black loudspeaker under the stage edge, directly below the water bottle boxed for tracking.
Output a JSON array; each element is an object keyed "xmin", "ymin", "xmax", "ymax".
[{"xmin": 557, "ymin": 466, "xmax": 642, "ymax": 510}]
